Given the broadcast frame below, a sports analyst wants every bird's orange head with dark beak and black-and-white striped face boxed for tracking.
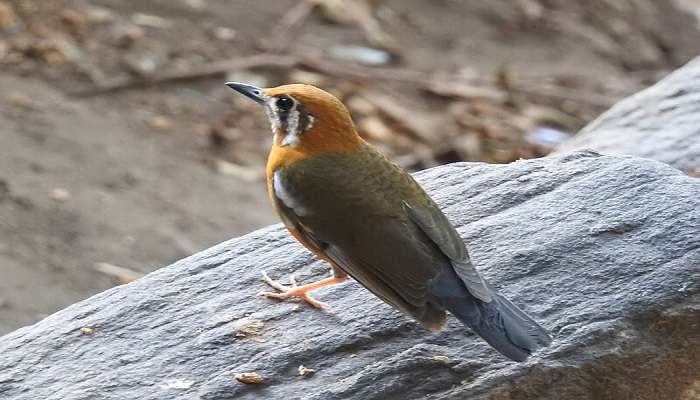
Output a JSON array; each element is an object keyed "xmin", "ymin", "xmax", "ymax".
[{"xmin": 226, "ymin": 82, "xmax": 363, "ymax": 155}]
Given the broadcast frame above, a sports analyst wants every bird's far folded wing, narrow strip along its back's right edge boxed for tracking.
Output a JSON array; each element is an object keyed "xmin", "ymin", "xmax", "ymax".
[{"xmin": 403, "ymin": 201, "xmax": 493, "ymax": 303}]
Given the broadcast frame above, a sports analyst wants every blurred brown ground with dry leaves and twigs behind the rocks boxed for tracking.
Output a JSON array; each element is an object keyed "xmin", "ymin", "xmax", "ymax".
[{"xmin": 0, "ymin": 0, "xmax": 700, "ymax": 334}]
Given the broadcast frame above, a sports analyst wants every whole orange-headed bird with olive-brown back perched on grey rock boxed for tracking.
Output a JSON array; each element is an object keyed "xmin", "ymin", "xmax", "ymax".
[{"xmin": 226, "ymin": 82, "xmax": 552, "ymax": 361}]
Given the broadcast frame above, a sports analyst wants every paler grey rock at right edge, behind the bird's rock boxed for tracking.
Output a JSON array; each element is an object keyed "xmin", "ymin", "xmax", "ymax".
[{"xmin": 558, "ymin": 58, "xmax": 700, "ymax": 174}]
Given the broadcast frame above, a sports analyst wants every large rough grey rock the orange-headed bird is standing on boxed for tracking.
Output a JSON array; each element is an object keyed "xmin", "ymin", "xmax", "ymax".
[{"xmin": 0, "ymin": 152, "xmax": 700, "ymax": 400}]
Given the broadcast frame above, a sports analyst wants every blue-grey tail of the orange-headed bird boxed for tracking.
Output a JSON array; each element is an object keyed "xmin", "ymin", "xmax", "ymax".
[{"xmin": 432, "ymin": 268, "xmax": 552, "ymax": 361}]
